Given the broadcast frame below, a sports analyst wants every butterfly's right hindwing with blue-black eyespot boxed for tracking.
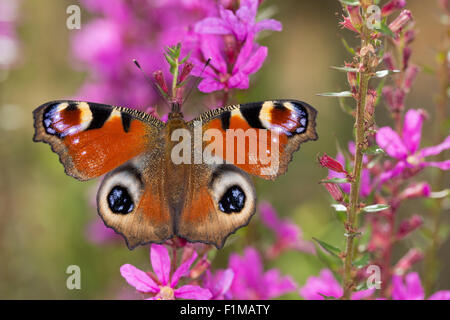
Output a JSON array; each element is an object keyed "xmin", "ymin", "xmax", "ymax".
[{"xmin": 175, "ymin": 164, "xmax": 256, "ymax": 249}]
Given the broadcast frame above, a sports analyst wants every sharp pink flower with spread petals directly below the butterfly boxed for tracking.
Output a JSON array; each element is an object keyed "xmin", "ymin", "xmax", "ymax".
[{"xmin": 120, "ymin": 244, "xmax": 212, "ymax": 300}]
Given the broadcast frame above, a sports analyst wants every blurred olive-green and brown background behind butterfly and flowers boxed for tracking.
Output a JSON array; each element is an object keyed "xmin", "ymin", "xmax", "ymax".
[{"xmin": 0, "ymin": 0, "xmax": 450, "ymax": 299}]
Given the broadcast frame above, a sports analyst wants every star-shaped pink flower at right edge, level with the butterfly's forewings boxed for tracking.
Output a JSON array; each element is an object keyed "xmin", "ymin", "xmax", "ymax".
[{"xmin": 376, "ymin": 109, "xmax": 450, "ymax": 183}]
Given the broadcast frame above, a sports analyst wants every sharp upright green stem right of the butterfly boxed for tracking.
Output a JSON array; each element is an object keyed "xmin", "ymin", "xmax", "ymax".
[{"xmin": 343, "ymin": 40, "xmax": 371, "ymax": 300}]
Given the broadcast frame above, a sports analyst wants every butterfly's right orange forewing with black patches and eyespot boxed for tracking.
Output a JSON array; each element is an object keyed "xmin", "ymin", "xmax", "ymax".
[{"xmin": 189, "ymin": 100, "xmax": 317, "ymax": 180}]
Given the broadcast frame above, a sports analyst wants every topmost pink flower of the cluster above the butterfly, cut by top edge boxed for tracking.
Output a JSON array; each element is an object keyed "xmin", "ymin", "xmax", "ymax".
[{"xmin": 194, "ymin": 0, "xmax": 282, "ymax": 42}]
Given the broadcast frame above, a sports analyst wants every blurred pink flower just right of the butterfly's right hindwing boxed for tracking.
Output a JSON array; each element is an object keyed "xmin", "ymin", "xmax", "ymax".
[{"xmin": 259, "ymin": 202, "xmax": 315, "ymax": 258}]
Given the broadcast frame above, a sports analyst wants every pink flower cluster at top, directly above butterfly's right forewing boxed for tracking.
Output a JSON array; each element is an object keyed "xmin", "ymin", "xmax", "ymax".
[{"xmin": 193, "ymin": 0, "xmax": 282, "ymax": 92}]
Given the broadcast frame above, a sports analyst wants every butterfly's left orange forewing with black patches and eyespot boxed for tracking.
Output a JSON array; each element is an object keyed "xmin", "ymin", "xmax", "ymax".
[{"xmin": 33, "ymin": 100, "xmax": 164, "ymax": 180}]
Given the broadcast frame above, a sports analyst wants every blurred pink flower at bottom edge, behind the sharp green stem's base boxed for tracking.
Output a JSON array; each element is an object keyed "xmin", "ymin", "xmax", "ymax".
[{"xmin": 299, "ymin": 269, "xmax": 375, "ymax": 300}]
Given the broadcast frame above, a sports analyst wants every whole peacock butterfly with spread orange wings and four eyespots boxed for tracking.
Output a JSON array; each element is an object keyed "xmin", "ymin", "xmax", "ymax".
[{"xmin": 34, "ymin": 100, "xmax": 317, "ymax": 248}]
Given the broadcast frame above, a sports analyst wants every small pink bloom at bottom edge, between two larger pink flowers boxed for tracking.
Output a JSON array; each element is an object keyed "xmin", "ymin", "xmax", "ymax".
[{"xmin": 203, "ymin": 269, "xmax": 234, "ymax": 300}]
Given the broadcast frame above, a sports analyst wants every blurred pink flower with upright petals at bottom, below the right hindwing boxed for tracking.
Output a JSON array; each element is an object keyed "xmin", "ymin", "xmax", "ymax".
[{"xmin": 229, "ymin": 247, "xmax": 297, "ymax": 300}]
